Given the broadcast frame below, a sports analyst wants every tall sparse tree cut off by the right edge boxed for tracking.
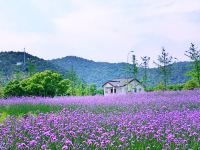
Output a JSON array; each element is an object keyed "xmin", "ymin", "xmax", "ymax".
[{"xmin": 185, "ymin": 43, "xmax": 200, "ymax": 87}]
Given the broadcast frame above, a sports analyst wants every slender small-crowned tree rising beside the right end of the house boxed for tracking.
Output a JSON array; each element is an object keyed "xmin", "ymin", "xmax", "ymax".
[{"xmin": 141, "ymin": 56, "xmax": 150, "ymax": 85}]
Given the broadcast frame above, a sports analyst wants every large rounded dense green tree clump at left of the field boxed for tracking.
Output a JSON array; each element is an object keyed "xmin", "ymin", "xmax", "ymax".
[{"xmin": 4, "ymin": 70, "xmax": 62, "ymax": 97}]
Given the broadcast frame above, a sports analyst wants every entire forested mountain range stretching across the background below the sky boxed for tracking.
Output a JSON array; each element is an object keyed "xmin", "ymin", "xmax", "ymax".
[{"xmin": 0, "ymin": 52, "xmax": 190, "ymax": 87}]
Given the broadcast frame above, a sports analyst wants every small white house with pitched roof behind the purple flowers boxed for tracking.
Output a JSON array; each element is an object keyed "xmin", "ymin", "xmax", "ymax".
[{"xmin": 103, "ymin": 78, "xmax": 144, "ymax": 95}]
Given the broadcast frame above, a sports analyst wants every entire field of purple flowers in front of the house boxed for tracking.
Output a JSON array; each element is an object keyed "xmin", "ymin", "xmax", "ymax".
[{"xmin": 0, "ymin": 90, "xmax": 200, "ymax": 150}]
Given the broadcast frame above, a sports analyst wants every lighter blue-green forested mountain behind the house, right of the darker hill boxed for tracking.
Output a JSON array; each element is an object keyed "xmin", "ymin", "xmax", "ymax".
[{"xmin": 50, "ymin": 56, "xmax": 191, "ymax": 86}]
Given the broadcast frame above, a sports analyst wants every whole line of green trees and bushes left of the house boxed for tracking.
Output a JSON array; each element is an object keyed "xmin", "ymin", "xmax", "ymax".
[{"xmin": 0, "ymin": 69, "xmax": 103, "ymax": 97}]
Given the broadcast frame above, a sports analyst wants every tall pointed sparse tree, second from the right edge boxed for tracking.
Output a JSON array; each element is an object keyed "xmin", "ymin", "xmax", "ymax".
[{"xmin": 154, "ymin": 48, "xmax": 176, "ymax": 90}]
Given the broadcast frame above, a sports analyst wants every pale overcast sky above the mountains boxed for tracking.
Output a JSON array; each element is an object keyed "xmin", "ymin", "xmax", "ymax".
[{"xmin": 0, "ymin": 0, "xmax": 200, "ymax": 62}]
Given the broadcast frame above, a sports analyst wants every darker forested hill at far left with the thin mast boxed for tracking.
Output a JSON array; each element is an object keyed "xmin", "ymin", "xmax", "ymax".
[{"xmin": 0, "ymin": 51, "xmax": 63, "ymax": 80}]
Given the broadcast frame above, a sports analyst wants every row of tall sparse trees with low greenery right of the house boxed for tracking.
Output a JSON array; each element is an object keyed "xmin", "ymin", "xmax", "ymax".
[{"xmin": 129, "ymin": 43, "xmax": 200, "ymax": 91}]
